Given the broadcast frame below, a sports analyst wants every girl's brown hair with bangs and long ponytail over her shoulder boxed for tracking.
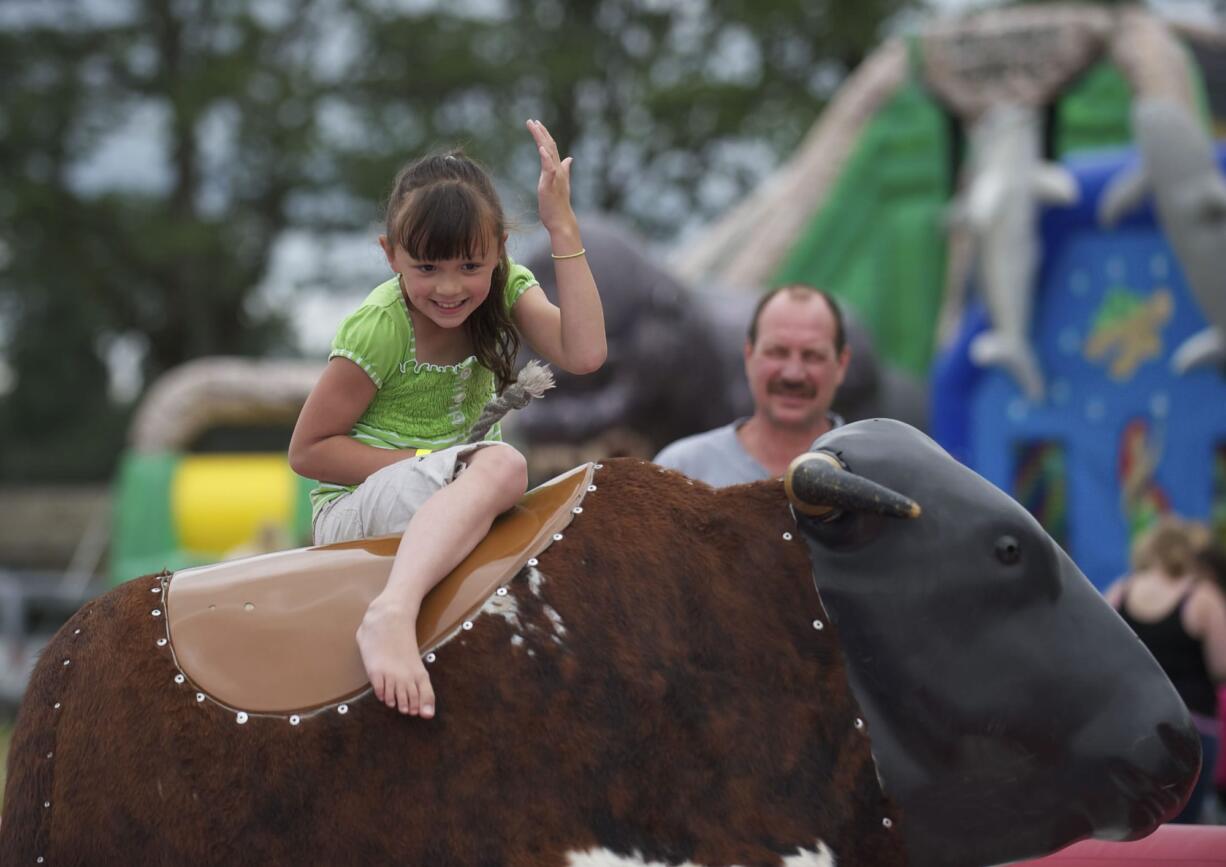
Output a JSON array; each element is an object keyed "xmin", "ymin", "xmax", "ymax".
[{"xmin": 387, "ymin": 150, "xmax": 520, "ymax": 391}]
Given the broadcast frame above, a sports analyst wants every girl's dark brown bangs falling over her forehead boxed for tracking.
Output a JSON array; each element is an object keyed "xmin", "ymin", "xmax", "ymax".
[{"xmin": 397, "ymin": 184, "xmax": 498, "ymax": 262}]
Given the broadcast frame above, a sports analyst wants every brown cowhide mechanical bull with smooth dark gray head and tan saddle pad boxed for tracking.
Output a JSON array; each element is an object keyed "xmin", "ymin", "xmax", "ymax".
[{"xmin": 0, "ymin": 419, "xmax": 1199, "ymax": 867}]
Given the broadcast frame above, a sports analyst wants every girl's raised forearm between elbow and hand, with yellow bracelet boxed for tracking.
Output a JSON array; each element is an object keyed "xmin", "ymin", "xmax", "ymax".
[{"xmin": 549, "ymin": 224, "xmax": 608, "ymax": 374}]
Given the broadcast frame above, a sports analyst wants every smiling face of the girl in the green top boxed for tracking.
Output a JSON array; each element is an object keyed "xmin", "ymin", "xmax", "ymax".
[{"xmin": 379, "ymin": 238, "xmax": 501, "ymax": 329}]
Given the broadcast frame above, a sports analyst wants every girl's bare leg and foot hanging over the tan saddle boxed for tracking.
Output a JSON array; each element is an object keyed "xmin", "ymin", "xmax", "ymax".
[{"xmin": 358, "ymin": 446, "xmax": 527, "ymax": 719}]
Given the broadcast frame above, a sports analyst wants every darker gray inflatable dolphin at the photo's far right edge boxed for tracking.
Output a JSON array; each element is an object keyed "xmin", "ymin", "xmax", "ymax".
[{"xmin": 1098, "ymin": 99, "xmax": 1226, "ymax": 374}]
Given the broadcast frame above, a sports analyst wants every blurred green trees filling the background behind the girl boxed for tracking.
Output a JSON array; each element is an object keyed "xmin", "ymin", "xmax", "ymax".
[{"xmin": 0, "ymin": 0, "xmax": 918, "ymax": 479}]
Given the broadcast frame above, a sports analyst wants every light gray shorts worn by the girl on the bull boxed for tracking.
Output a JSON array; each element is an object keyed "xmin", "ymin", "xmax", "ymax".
[{"xmin": 313, "ymin": 440, "xmax": 506, "ymax": 544}]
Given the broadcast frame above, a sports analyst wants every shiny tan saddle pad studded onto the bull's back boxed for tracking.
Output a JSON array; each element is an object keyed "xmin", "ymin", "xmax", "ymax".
[{"xmin": 166, "ymin": 464, "xmax": 593, "ymax": 714}]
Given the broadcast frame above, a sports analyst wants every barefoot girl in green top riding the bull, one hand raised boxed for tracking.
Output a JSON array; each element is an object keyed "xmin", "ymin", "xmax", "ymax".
[{"xmin": 289, "ymin": 120, "xmax": 606, "ymax": 717}]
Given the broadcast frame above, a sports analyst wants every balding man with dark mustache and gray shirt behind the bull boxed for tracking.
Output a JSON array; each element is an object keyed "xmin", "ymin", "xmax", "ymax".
[{"xmin": 655, "ymin": 285, "xmax": 851, "ymax": 487}]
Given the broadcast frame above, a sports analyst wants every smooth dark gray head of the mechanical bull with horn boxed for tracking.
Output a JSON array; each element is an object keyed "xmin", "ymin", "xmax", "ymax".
[{"xmin": 786, "ymin": 419, "xmax": 1200, "ymax": 867}]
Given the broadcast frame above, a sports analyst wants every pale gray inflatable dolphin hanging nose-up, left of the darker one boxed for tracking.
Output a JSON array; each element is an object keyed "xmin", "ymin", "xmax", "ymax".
[{"xmin": 950, "ymin": 103, "xmax": 1078, "ymax": 401}]
